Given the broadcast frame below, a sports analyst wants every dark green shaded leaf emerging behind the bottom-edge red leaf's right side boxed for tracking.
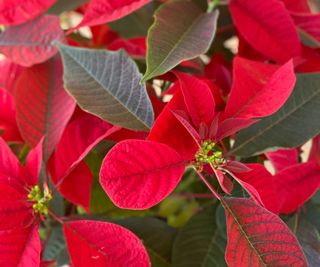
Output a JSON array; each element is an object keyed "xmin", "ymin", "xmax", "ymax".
[{"xmin": 117, "ymin": 218, "xmax": 177, "ymax": 267}]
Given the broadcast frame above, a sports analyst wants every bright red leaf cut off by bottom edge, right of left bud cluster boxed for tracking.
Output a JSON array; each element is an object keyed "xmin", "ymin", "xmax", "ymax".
[{"xmin": 64, "ymin": 220, "xmax": 151, "ymax": 267}]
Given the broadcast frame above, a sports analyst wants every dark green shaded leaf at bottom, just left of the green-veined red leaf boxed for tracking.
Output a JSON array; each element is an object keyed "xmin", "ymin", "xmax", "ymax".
[{"xmin": 172, "ymin": 207, "xmax": 226, "ymax": 267}]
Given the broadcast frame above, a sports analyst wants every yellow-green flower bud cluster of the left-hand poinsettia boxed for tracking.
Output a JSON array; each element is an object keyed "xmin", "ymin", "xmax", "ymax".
[{"xmin": 28, "ymin": 185, "xmax": 52, "ymax": 216}]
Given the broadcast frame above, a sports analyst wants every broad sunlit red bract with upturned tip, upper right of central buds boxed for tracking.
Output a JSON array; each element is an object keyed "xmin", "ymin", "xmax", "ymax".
[{"xmin": 225, "ymin": 57, "xmax": 296, "ymax": 118}]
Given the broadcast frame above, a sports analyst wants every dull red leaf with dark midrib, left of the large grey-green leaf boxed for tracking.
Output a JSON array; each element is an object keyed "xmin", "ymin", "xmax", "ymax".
[{"xmin": 15, "ymin": 57, "xmax": 75, "ymax": 159}]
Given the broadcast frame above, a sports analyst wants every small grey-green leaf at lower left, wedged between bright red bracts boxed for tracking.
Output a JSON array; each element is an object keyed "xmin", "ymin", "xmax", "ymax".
[{"xmin": 43, "ymin": 226, "xmax": 69, "ymax": 266}]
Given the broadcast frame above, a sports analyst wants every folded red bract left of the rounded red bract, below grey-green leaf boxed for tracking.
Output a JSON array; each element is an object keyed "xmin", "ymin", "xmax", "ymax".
[{"xmin": 50, "ymin": 114, "xmax": 119, "ymax": 210}]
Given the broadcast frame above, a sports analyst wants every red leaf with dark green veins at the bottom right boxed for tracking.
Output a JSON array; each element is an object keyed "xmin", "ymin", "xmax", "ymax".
[{"xmin": 222, "ymin": 198, "xmax": 308, "ymax": 267}]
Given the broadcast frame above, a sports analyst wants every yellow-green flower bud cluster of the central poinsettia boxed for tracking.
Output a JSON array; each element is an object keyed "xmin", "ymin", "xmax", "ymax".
[{"xmin": 195, "ymin": 140, "xmax": 225, "ymax": 167}]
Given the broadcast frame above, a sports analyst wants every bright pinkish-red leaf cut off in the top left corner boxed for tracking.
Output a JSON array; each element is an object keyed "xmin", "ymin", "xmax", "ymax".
[{"xmin": 0, "ymin": 0, "xmax": 56, "ymax": 25}]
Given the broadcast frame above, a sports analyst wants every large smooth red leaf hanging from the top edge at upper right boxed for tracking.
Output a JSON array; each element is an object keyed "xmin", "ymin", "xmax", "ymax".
[{"xmin": 230, "ymin": 0, "xmax": 300, "ymax": 63}]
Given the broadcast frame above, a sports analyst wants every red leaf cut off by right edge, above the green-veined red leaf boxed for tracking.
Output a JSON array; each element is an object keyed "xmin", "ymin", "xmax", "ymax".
[{"xmin": 273, "ymin": 162, "xmax": 320, "ymax": 213}]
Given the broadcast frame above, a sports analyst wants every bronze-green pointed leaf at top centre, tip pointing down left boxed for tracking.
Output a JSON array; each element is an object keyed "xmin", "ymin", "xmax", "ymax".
[{"xmin": 143, "ymin": 0, "xmax": 218, "ymax": 81}]
